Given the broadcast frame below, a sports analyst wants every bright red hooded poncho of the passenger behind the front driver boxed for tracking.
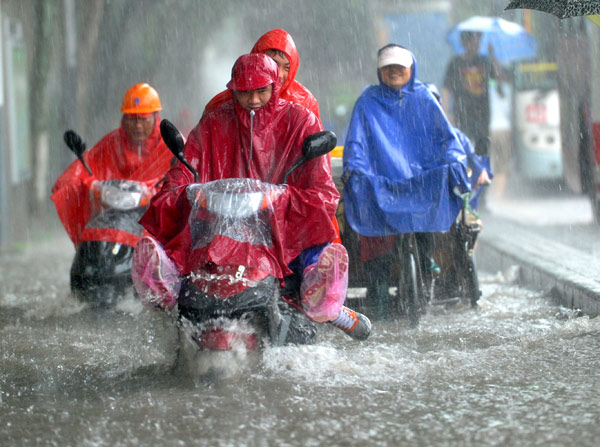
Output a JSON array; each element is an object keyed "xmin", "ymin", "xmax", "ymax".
[{"xmin": 204, "ymin": 29, "xmax": 319, "ymax": 118}]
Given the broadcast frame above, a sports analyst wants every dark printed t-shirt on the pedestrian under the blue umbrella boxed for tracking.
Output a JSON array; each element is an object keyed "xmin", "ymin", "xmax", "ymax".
[{"xmin": 444, "ymin": 56, "xmax": 492, "ymax": 141}]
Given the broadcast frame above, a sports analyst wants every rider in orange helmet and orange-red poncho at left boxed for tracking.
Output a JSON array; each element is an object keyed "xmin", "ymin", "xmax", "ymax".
[{"xmin": 51, "ymin": 83, "xmax": 173, "ymax": 247}]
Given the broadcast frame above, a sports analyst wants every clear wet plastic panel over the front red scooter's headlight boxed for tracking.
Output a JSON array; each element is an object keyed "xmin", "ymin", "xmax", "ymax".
[{"xmin": 187, "ymin": 178, "xmax": 285, "ymax": 249}]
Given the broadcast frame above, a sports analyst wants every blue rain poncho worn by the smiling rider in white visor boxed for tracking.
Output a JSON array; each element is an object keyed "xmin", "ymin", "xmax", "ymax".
[{"xmin": 343, "ymin": 50, "xmax": 471, "ymax": 236}]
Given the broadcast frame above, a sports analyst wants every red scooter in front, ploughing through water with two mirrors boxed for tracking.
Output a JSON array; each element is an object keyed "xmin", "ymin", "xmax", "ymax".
[{"xmin": 160, "ymin": 120, "xmax": 336, "ymax": 351}]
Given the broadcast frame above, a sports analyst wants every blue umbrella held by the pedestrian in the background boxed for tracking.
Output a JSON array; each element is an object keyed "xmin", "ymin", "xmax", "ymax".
[{"xmin": 447, "ymin": 16, "xmax": 537, "ymax": 65}]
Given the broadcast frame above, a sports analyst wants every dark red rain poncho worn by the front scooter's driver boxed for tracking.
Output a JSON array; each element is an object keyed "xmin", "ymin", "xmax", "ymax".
[{"xmin": 140, "ymin": 54, "xmax": 339, "ymax": 278}]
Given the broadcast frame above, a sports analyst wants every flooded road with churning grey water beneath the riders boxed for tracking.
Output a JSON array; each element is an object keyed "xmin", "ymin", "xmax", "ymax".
[{"xmin": 0, "ymin": 239, "xmax": 600, "ymax": 446}]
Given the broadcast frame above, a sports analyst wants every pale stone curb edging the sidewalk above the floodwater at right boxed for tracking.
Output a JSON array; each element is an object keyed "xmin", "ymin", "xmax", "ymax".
[{"xmin": 476, "ymin": 216, "xmax": 600, "ymax": 317}]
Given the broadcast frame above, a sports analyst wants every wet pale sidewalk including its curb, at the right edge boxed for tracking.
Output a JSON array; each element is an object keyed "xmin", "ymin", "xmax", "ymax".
[{"xmin": 477, "ymin": 178, "xmax": 600, "ymax": 316}]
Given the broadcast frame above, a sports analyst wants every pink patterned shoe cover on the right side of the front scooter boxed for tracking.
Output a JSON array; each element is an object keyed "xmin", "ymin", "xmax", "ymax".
[{"xmin": 300, "ymin": 243, "xmax": 348, "ymax": 323}]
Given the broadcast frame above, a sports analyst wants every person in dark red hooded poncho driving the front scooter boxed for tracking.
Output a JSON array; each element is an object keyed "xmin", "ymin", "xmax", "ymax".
[{"xmin": 134, "ymin": 54, "xmax": 370, "ymax": 338}]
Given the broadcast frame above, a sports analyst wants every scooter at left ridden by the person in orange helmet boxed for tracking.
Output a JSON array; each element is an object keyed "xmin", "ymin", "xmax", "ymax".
[{"xmin": 64, "ymin": 130, "xmax": 152, "ymax": 307}]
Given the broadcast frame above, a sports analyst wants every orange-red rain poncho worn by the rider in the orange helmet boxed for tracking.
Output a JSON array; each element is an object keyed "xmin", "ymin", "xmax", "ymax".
[{"xmin": 50, "ymin": 114, "xmax": 173, "ymax": 247}]
